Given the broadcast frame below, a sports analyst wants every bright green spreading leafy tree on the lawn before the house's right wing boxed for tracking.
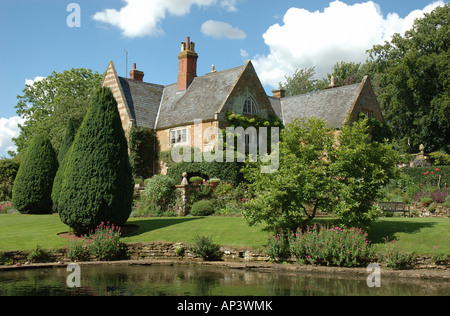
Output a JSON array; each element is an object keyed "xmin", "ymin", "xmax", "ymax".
[{"xmin": 244, "ymin": 118, "xmax": 396, "ymax": 231}]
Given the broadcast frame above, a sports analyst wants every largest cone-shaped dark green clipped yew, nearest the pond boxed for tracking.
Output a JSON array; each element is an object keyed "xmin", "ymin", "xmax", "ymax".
[{"xmin": 59, "ymin": 88, "xmax": 133, "ymax": 234}]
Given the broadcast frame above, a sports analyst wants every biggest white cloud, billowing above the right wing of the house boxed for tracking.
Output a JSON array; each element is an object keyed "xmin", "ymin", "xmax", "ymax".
[{"xmin": 253, "ymin": 0, "xmax": 444, "ymax": 87}]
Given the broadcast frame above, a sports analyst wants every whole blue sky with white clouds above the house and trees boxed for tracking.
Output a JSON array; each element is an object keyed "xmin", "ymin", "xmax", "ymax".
[{"xmin": 0, "ymin": 0, "xmax": 448, "ymax": 156}]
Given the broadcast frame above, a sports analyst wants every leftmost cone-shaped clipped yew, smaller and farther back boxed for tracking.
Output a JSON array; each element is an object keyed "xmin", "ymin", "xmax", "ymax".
[{"xmin": 13, "ymin": 134, "xmax": 58, "ymax": 214}]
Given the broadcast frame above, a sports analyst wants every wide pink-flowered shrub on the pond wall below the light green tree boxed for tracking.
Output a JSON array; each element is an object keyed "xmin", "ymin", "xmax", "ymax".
[{"xmin": 289, "ymin": 225, "xmax": 374, "ymax": 267}]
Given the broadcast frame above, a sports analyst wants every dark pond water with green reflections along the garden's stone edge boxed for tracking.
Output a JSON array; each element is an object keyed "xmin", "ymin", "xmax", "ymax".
[{"xmin": 0, "ymin": 265, "xmax": 450, "ymax": 296}]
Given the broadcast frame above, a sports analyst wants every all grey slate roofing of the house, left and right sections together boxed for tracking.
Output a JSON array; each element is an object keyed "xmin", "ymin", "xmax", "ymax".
[{"xmin": 114, "ymin": 60, "xmax": 360, "ymax": 129}]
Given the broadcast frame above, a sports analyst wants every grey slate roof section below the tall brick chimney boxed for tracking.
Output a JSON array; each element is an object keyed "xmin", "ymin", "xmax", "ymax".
[{"xmin": 119, "ymin": 66, "xmax": 245, "ymax": 129}]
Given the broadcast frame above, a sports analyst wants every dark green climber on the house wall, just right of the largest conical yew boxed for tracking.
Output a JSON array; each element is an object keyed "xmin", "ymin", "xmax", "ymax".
[{"xmin": 129, "ymin": 125, "xmax": 157, "ymax": 179}]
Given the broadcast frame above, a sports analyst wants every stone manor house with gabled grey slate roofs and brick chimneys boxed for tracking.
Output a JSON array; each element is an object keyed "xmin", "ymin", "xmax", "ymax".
[{"xmin": 103, "ymin": 37, "xmax": 383, "ymax": 173}]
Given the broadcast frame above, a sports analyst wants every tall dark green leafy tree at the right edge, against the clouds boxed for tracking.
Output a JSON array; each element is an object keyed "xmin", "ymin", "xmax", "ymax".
[{"xmin": 369, "ymin": 4, "xmax": 450, "ymax": 152}]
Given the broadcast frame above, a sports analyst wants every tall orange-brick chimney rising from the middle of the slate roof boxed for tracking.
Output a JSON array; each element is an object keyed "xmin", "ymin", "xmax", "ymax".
[{"xmin": 177, "ymin": 37, "xmax": 198, "ymax": 91}]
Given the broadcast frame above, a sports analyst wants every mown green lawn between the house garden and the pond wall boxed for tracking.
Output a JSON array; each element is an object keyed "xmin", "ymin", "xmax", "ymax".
[{"xmin": 0, "ymin": 214, "xmax": 450, "ymax": 254}]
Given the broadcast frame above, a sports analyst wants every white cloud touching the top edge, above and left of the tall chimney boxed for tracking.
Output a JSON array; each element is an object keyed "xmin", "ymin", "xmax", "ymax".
[{"xmin": 93, "ymin": 0, "xmax": 237, "ymax": 38}]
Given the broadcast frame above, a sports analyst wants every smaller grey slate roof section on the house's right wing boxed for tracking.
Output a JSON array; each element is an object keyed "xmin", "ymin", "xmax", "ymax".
[{"xmin": 280, "ymin": 83, "xmax": 360, "ymax": 128}]
